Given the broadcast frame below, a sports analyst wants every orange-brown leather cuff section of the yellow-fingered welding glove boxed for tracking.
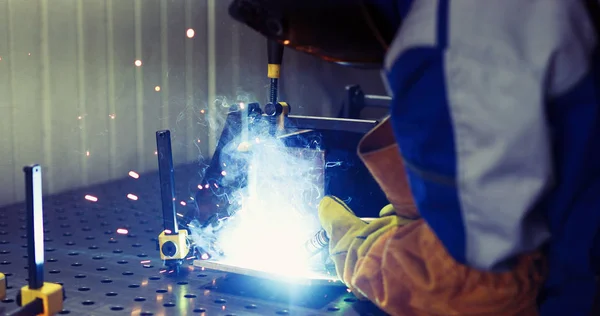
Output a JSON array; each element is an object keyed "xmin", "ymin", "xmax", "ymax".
[{"xmin": 350, "ymin": 220, "xmax": 543, "ymax": 316}]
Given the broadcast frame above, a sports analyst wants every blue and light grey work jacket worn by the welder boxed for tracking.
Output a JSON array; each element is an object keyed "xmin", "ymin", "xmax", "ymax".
[{"xmin": 373, "ymin": 0, "xmax": 600, "ymax": 315}]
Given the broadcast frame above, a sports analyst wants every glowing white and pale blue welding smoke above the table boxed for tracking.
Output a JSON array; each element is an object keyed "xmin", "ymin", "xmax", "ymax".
[{"xmin": 188, "ymin": 96, "xmax": 325, "ymax": 275}]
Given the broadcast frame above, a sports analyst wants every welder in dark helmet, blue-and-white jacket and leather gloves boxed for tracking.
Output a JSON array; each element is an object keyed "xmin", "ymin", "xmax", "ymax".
[{"xmin": 230, "ymin": 0, "xmax": 600, "ymax": 315}]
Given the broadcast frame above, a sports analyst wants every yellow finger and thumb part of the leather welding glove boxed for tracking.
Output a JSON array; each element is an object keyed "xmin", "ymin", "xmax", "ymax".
[{"xmin": 319, "ymin": 196, "xmax": 414, "ymax": 298}]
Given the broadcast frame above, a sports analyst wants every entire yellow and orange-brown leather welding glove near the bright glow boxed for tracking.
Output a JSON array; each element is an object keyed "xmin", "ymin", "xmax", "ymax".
[{"xmin": 319, "ymin": 197, "xmax": 543, "ymax": 316}]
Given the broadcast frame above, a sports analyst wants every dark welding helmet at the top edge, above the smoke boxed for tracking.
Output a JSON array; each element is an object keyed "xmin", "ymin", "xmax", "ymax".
[{"xmin": 229, "ymin": 0, "xmax": 400, "ymax": 67}]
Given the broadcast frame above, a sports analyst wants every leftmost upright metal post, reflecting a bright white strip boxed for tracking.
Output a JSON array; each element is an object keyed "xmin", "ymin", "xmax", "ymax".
[{"xmin": 23, "ymin": 165, "xmax": 44, "ymax": 289}]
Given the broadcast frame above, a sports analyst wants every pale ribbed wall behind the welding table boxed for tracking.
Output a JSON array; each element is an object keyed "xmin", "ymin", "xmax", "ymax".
[{"xmin": 0, "ymin": 0, "xmax": 384, "ymax": 205}]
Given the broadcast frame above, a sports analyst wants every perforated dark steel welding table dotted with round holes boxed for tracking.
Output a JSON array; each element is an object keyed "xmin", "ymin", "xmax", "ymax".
[{"xmin": 0, "ymin": 167, "xmax": 383, "ymax": 315}]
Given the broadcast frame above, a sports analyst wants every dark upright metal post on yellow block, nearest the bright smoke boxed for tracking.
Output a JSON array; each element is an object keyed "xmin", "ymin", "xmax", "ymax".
[{"xmin": 156, "ymin": 130, "xmax": 178, "ymax": 235}]
